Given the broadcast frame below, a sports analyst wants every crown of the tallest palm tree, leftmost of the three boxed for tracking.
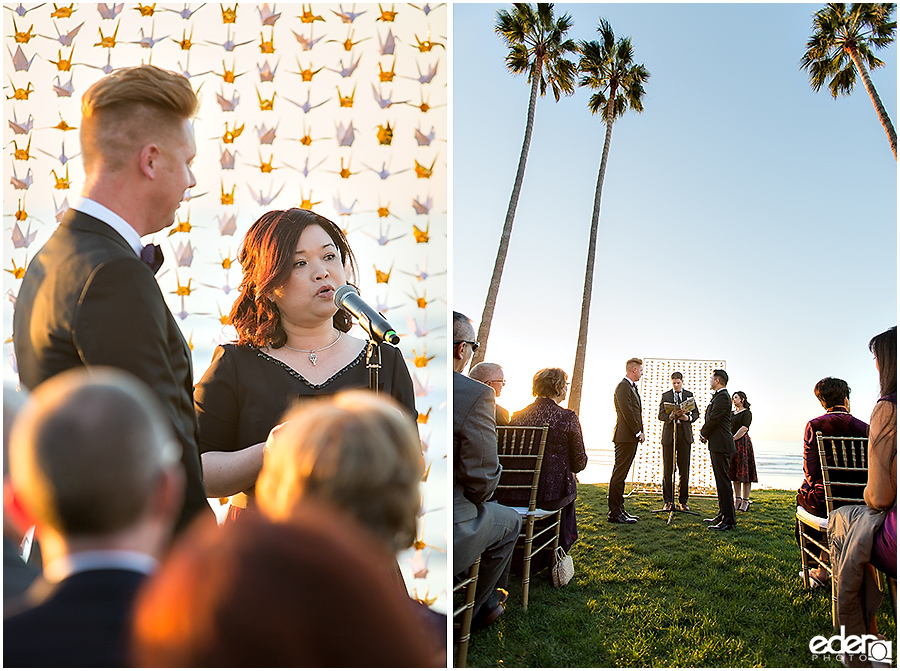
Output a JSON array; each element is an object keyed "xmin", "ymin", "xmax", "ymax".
[{"xmin": 494, "ymin": 2, "xmax": 577, "ymax": 101}]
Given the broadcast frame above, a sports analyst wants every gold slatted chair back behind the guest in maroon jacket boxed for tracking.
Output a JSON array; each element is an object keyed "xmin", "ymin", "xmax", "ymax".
[{"xmin": 816, "ymin": 431, "xmax": 869, "ymax": 514}]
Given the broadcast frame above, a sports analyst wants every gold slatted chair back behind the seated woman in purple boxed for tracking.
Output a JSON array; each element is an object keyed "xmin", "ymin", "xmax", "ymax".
[{"xmin": 497, "ymin": 425, "xmax": 550, "ymax": 512}]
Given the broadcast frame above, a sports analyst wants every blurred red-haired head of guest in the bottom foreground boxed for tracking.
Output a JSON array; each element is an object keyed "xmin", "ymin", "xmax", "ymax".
[{"xmin": 132, "ymin": 502, "xmax": 446, "ymax": 668}]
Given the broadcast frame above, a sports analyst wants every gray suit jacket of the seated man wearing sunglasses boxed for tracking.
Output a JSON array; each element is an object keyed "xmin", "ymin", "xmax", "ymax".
[{"xmin": 453, "ymin": 371, "xmax": 500, "ymax": 524}]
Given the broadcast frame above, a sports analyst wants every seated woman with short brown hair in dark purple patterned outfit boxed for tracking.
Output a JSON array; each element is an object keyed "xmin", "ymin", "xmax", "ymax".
[{"xmin": 506, "ymin": 368, "xmax": 587, "ymax": 570}]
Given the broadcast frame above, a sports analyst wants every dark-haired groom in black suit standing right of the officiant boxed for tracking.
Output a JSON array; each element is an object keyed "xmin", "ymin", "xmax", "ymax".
[{"xmin": 700, "ymin": 368, "xmax": 736, "ymax": 531}]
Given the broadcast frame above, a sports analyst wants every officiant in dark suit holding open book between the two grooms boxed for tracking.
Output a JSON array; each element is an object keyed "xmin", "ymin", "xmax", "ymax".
[{"xmin": 659, "ymin": 371, "xmax": 700, "ymax": 511}]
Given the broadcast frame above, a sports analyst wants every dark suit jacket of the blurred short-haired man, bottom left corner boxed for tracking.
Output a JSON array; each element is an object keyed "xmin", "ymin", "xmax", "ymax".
[{"xmin": 3, "ymin": 569, "xmax": 146, "ymax": 668}]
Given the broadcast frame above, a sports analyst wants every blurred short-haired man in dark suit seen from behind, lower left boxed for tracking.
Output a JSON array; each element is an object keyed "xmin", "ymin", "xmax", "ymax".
[{"xmin": 3, "ymin": 367, "xmax": 184, "ymax": 668}]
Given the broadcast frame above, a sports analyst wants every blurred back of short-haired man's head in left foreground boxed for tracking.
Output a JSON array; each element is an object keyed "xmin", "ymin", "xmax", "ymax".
[{"xmin": 10, "ymin": 368, "xmax": 181, "ymax": 538}]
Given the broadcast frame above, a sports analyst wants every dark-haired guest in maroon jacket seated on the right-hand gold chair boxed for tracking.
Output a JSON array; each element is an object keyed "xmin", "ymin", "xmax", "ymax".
[{"xmin": 795, "ymin": 377, "xmax": 869, "ymax": 586}]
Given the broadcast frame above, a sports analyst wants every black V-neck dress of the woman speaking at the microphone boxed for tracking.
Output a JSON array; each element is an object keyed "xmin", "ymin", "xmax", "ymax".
[{"xmin": 194, "ymin": 343, "xmax": 418, "ymax": 506}]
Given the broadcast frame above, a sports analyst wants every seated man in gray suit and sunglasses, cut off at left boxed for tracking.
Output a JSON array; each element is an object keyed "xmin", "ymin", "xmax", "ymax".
[{"xmin": 453, "ymin": 312, "xmax": 522, "ymax": 628}]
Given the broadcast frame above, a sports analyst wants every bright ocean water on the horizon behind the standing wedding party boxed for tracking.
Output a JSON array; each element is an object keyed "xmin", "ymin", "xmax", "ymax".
[{"xmin": 578, "ymin": 439, "xmax": 803, "ymax": 490}]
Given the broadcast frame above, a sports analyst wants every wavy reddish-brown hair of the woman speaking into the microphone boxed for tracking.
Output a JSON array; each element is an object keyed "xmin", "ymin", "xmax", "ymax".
[{"xmin": 230, "ymin": 207, "xmax": 356, "ymax": 348}]
